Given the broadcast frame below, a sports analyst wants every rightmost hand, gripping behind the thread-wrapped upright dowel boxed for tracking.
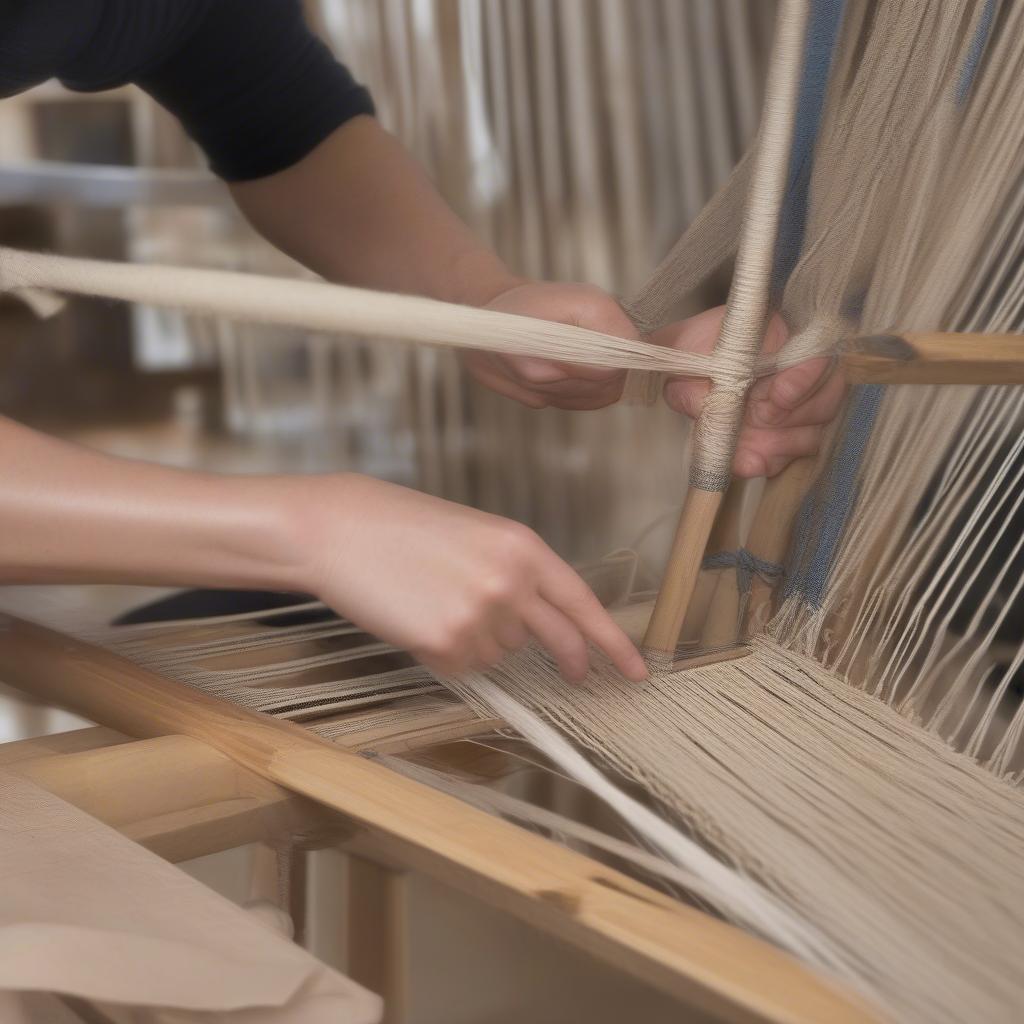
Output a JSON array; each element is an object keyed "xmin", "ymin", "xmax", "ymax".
[{"xmin": 651, "ymin": 306, "xmax": 846, "ymax": 477}]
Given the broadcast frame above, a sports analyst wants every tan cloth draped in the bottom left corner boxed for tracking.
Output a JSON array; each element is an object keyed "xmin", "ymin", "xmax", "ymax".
[{"xmin": 0, "ymin": 774, "xmax": 381, "ymax": 1024}]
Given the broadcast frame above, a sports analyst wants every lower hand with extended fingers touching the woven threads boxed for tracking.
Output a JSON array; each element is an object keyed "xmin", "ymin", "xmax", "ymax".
[{"xmin": 297, "ymin": 474, "xmax": 647, "ymax": 681}]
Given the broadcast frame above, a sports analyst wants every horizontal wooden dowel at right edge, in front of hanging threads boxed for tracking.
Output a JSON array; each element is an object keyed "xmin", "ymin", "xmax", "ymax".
[{"xmin": 842, "ymin": 332, "xmax": 1024, "ymax": 384}]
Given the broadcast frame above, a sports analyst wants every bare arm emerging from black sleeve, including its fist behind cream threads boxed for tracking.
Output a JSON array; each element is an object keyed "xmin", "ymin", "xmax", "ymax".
[{"xmin": 231, "ymin": 117, "xmax": 636, "ymax": 409}]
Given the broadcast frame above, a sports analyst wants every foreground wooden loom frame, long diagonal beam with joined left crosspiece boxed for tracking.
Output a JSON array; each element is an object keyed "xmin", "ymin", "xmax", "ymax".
[{"xmin": 0, "ymin": 616, "xmax": 877, "ymax": 1024}]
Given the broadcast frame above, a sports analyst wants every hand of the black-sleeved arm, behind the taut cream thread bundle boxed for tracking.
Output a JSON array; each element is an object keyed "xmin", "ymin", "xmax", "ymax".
[{"xmin": 462, "ymin": 282, "xmax": 637, "ymax": 410}]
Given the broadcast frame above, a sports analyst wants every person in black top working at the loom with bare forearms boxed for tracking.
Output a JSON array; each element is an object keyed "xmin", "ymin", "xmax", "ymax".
[{"xmin": 0, "ymin": 8, "xmax": 835, "ymax": 680}]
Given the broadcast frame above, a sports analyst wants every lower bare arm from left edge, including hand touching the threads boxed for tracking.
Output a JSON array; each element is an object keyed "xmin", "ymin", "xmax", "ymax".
[{"xmin": 0, "ymin": 419, "xmax": 645, "ymax": 679}]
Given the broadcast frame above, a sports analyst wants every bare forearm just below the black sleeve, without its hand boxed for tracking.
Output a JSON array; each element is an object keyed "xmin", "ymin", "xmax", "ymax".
[{"xmin": 231, "ymin": 117, "xmax": 519, "ymax": 305}]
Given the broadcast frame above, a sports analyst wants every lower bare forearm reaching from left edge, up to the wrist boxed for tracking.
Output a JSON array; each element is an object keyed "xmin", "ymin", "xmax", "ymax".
[{"xmin": 0, "ymin": 419, "xmax": 308, "ymax": 590}]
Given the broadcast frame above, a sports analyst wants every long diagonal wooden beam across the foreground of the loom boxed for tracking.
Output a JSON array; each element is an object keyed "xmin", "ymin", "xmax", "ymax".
[{"xmin": 0, "ymin": 616, "xmax": 877, "ymax": 1024}]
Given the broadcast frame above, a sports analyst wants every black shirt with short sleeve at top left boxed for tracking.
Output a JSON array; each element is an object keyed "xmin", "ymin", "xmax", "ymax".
[{"xmin": 0, "ymin": 0, "xmax": 373, "ymax": 181}]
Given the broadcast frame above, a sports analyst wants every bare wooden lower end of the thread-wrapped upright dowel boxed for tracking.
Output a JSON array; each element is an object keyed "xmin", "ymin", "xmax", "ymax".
[{"xmin": 643, "ymin": 486, "xmax": 723, "ymax": 653}]
